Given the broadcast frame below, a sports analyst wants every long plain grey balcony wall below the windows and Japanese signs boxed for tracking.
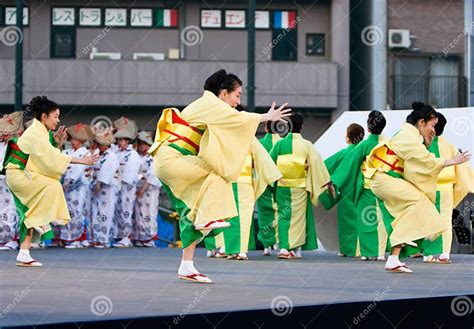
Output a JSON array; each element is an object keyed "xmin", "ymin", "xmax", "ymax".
[{"xmin": 0, "ymin": 59, "xmax": 338, "ymax": 108}]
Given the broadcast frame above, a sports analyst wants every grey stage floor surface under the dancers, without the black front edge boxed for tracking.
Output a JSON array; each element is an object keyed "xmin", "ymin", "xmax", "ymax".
[{"xmin": 0, "ymin": 248, "xmax": 474, "ymax": 327}]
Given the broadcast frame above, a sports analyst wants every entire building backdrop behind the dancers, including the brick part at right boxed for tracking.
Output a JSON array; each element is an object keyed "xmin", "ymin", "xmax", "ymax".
[{"xmin": 0, "ymin": 0, "xmax": 474, "ymax": 140}]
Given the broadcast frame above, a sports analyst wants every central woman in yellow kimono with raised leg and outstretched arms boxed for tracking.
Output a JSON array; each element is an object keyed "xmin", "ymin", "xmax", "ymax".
[{"xmin": 149, "ymin": 70, "xmax": 291, "ymax": 283}]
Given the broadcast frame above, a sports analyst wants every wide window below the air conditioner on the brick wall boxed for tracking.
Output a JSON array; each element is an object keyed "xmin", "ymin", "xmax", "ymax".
[{"xmin": 393, "ymin": 56, "xmax": 462, "ymax": 109}]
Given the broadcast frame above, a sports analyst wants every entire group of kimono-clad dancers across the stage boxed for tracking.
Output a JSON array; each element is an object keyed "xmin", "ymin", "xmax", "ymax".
[{"xmin": 0, "ymin": 70, "xmax": 474, "ymax": 283}]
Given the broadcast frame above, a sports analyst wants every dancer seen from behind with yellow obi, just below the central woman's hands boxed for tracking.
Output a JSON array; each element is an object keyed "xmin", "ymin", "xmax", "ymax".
[{"xmin": 270, "ymin": 113, "xmax": 334, "ymax": 259}]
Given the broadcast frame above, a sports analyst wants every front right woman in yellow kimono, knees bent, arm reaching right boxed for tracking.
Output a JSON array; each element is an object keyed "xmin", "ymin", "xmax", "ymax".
[{"xmin": 365, "ymin": 102, "xmax": 470, "ymax": 273}]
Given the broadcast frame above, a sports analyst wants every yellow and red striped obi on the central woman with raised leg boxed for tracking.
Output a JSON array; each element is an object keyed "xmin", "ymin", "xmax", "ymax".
[{"xmin": 155, "ymin": 108, "xmax": 205, "ymax": 155}]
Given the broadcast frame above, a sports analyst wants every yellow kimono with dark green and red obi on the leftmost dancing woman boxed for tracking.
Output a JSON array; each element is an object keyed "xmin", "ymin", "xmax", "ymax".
[{"xmin": 4, "ymin": 119, "xmax": 71, "ymax": 240}]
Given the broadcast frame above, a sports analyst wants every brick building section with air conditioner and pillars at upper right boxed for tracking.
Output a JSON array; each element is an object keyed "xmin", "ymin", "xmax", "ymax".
[{"xmin": 350, "ymin": 0, "xmax": 473, "ymax": 110}]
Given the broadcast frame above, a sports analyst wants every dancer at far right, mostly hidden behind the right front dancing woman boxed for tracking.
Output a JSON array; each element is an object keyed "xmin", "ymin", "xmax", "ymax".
[{"xmin": 423, "ymin": 113, "xmax": 474, "ymax": 264}]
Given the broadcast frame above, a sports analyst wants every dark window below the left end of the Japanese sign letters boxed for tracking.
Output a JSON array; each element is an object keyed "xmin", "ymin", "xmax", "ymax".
[{"xmin": 51, "ymin": 26, "xmax": 76, "ymax": 58}]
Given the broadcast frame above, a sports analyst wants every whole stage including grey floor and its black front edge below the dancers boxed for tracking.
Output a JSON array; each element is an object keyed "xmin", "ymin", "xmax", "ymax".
[{"xmin": 0, "ymin": 248, "xmax": 474, "ymax": 328}]
